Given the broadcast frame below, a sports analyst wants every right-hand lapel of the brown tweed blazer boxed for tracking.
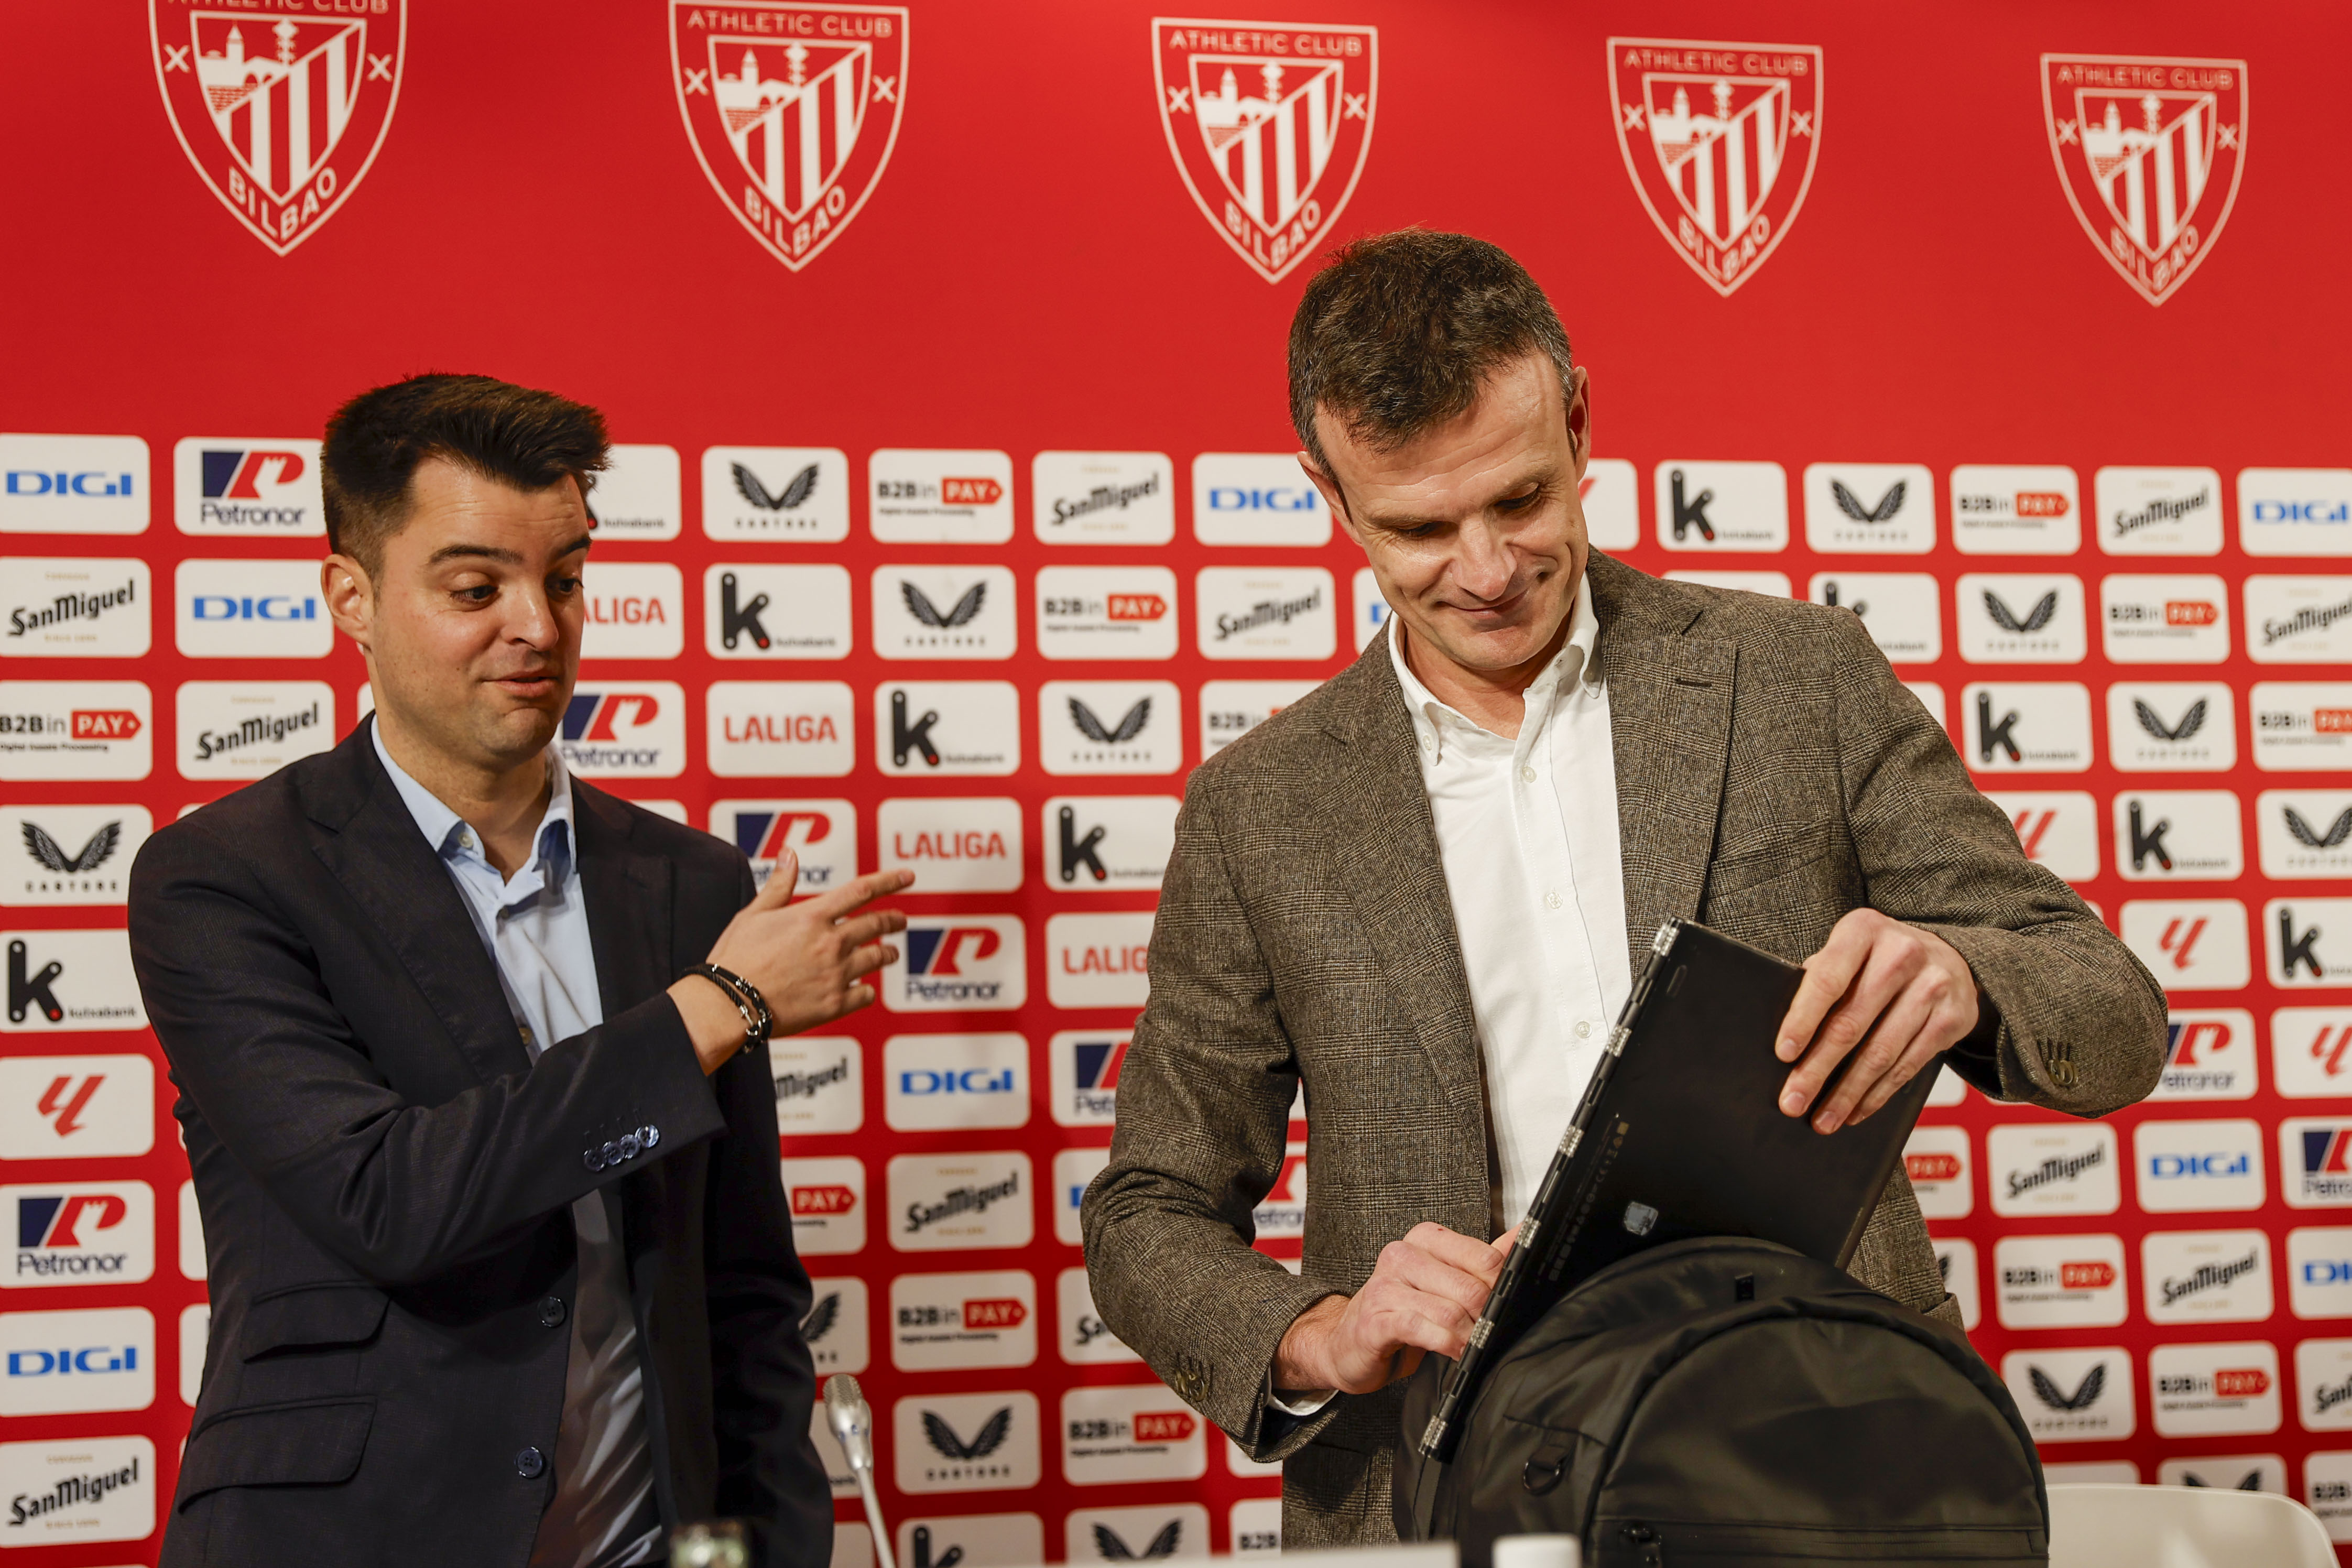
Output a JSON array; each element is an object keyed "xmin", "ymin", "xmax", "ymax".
[{"xmin": 1587, "ymin": 552, "xmax": 1738, "ymax": 973}]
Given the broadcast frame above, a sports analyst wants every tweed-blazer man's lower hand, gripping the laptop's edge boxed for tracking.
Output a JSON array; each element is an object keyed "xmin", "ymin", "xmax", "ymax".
[{"xmin": 1275, "ymin": 1220, "xmax": 1519, "ymax": 1394}]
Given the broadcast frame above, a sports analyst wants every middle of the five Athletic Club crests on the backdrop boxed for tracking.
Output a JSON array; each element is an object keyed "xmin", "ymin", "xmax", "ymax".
[{"xmin": 1152, "ymin": 16, "xmax": 1380, "ymax": 282}]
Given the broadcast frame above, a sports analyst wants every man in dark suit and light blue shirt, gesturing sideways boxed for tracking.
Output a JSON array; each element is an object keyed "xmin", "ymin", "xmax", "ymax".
[{"xmin": 129, "ymin": 376, "xmax": 908, "ymax": 1568}]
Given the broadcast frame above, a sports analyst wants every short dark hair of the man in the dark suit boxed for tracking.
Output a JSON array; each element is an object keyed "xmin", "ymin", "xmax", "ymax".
[{"xmin": 320, "ymin": 376, "xmax": 612, "ymax": 576}]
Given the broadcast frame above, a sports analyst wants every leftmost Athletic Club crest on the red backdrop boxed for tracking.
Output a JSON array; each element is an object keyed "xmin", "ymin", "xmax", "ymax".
[{"xmin": 148, "ymin": 0, "xmax": 409, "ymax": 256}]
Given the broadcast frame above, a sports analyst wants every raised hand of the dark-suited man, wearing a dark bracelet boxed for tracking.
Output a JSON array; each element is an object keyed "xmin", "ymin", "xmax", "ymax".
[{"xmin": 670, "ymin": 851, "xmax": 915, "ymax": 1074}]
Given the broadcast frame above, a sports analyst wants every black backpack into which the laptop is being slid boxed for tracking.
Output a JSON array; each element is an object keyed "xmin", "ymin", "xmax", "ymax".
[{"xmin": 1395, "ymin": 1237, "xmax": 2049, "ymax": 1568}]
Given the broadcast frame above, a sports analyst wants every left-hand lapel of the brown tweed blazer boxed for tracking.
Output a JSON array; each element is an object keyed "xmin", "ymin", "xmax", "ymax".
[{"xmin": 1322, "ymin": 639, "xmax": 1484, "ymax": 1126}]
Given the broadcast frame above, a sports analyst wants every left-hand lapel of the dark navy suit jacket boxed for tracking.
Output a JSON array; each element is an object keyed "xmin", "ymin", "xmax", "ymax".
[{"xmin": 306, "ymin": 720, "xmax": 531, "ymax": 1081}]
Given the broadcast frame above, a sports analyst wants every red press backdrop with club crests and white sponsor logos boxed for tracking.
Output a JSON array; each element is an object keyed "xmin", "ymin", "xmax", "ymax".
[{"xmin": 0, "ymin": 0, "xmax": 2352, "ymax": 1568}]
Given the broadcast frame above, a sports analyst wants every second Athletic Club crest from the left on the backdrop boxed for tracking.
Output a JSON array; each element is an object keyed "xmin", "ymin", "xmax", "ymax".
[{"xmin": 670, "ymin": 0, "xmax": 906, "ymax": 273}]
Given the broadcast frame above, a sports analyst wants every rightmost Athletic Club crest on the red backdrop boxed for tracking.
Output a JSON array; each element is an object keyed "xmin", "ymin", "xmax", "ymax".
[{"xmin": 2042, "ymin": 54, "xmax": 2246, "ymax": 306}]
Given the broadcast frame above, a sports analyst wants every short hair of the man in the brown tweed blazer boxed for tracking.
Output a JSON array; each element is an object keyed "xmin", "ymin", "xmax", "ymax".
[{"xmin": 1291, "ymin": 228, "xmax": 1576, "ymax": 473}]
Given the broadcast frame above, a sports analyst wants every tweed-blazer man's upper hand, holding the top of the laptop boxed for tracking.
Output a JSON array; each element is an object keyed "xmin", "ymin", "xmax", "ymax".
[{"xmin": 1778, "ymin": 910, "xmax": 1976, "ymax": 1133}]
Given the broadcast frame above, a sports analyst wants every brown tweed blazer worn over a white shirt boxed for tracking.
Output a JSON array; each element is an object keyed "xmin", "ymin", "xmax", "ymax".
[{"xmin": 1084, "ymin": 552, "xmax": 2164, "ymax": 1547}]
